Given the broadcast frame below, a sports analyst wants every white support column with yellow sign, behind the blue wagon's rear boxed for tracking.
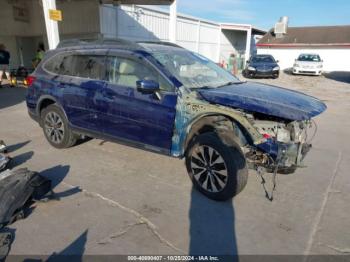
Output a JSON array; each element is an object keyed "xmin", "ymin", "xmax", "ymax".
[{"xmin": 42, "ymin": 0, "xmax": 60, "ymax": 49}]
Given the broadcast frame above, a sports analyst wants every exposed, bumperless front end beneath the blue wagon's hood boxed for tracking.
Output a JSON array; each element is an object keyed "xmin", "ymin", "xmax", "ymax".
[{"xmin": 246, "ymin": 115, "xmax": 316, "ymax": 174}]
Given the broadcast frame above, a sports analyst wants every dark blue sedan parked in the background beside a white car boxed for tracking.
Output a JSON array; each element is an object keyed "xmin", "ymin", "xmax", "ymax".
[{"xmin": 243, "ymin": 55, "xmax": 280, "ymax": 78}]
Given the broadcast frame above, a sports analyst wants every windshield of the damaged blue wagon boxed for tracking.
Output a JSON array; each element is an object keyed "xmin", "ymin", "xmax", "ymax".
[{"xmin": 151, "ymin": 49, "xmax": 240, "ymax": 88}]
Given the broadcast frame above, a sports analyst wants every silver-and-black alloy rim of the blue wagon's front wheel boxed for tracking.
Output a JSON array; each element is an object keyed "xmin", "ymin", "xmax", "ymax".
[{"xmin": 191, "ymin": 145, "xmax": 228, "ymax": 193}]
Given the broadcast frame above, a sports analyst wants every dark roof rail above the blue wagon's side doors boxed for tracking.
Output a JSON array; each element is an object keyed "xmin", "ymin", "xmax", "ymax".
[{"xmin": 57, "ymin": 38, "xmax": 140, "ymax": 48}]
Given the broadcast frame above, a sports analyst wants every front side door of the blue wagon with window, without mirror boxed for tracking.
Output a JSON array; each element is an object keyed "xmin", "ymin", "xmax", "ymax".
[{"xmin": 104, "ymin": 53, "xmax": 177, "ymax": 152}]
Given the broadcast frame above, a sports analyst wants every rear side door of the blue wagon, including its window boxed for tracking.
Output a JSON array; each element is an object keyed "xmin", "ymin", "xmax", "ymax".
[{"xmin": 49, "ymin": 51, "xmax": 106, "ymax": 132}]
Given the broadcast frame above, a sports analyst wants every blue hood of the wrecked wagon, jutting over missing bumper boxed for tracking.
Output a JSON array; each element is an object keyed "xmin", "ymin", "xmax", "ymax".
[{"xmin": 198, "ymin": 82, "xmax": 327, "ymax": 120}]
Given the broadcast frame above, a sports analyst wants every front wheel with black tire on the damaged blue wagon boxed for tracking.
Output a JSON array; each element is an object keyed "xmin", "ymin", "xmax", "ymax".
[{"xmin": 186, "ymin": 133, "xmax": 248, "ymax": 201}]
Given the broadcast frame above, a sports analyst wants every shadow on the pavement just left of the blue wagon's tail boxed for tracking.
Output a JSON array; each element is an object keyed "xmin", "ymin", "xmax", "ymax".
[{"xmin": 0, "ymin": 85, "xmax": 27, "ymax": 110}]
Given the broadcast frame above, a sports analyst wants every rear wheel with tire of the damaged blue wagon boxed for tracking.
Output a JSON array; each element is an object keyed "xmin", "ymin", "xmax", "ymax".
[{"xmin": 41, "ymin": 104, "xmax": 77, "ymax": 149}]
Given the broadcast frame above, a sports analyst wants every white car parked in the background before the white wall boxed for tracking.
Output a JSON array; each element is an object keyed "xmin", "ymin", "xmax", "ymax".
[{"xmin": 293, "ymin": 54, "xmax": 323, "ymax": 76}]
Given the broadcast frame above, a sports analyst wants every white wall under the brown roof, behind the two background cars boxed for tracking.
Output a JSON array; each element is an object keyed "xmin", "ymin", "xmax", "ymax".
[{"xmin": 258, "ymin": 47, "xmax": 350, "ymax": 72}]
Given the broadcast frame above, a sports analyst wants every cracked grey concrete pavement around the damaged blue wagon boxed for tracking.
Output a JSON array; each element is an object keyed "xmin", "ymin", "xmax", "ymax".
[{"xmin": 0, "ymin": 74, "xmax": 350, "ymax": 256}]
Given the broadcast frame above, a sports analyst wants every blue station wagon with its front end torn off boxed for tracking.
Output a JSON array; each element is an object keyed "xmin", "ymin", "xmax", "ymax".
[{"xmin": 26, "ymin": 40, "xmax": 326, "ymax": 200}]
